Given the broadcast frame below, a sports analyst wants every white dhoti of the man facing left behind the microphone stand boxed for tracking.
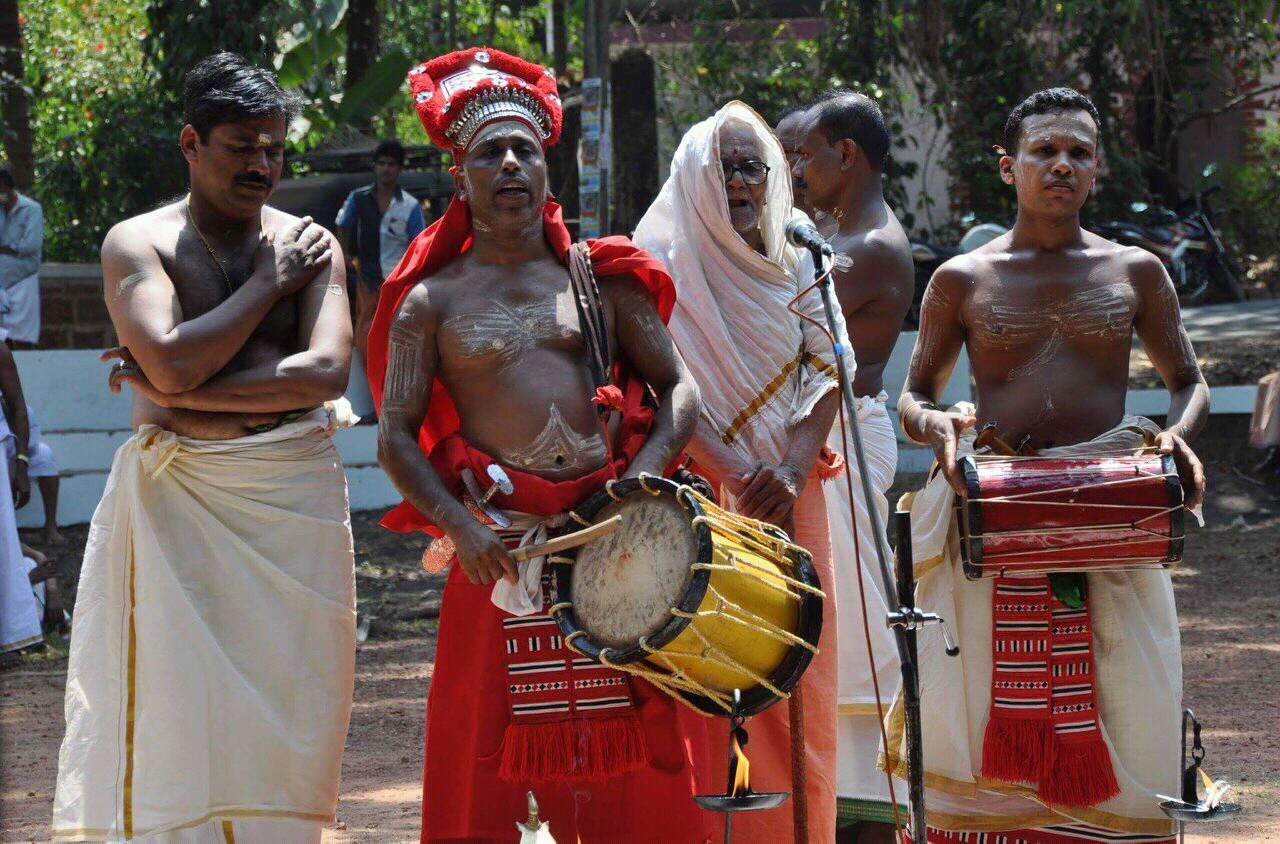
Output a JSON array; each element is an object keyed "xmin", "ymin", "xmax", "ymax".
[{"xmin": 824, "ymin": 393, "xmax": 906, "ymax": 822}]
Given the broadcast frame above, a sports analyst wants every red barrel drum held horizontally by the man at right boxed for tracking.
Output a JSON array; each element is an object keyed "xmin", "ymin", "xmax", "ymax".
[{"xmin": 957, "ymin": 455, "xmax": 1183, "ymax": 580}]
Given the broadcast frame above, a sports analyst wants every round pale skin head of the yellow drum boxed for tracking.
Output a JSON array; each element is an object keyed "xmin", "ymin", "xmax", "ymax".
[{"xmin": 571, "ymin": 492, "xmax": 698, "ymax": 648}]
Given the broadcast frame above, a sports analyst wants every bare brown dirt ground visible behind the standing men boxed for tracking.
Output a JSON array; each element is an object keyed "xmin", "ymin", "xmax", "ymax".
[{"xmin": 0, "ymin": 420, "xmax": 1280, "ymax": 841}]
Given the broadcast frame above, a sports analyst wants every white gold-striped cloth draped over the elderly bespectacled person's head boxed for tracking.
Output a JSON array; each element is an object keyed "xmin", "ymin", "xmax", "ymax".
[{"xmin": 634, "ymin": 101, "xmax": 854, "ymax": 465}]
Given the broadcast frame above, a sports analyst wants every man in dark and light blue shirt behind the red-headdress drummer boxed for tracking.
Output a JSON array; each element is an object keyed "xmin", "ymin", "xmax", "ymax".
[{"xmin": 335, "ymin": 141, "xmax": 425, "ymax": 369}]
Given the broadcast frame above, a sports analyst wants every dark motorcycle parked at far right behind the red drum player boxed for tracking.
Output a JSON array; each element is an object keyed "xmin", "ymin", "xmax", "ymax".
[{"xmin": 1093, "ymin": 164, "xmax": 1245, "ymax": 306}]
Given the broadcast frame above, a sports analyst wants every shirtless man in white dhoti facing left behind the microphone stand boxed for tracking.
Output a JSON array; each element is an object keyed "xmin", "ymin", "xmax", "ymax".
[{"xmin": 792, "ymin": 91, "xmax": 915, "ymax": 843}]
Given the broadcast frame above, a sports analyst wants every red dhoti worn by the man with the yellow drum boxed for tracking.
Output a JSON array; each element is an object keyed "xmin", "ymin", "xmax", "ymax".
[{"xmin": 388, "ymin": 432, "xmax": 723, "ymax": 844}]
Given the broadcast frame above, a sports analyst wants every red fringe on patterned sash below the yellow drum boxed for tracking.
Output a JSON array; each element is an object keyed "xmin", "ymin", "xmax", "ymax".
[{"xmin": 498, "ymin": 716, "xmax": 649, "ymax": 783}]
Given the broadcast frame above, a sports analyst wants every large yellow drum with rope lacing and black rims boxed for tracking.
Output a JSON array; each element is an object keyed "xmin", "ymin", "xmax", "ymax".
[{"xmin": 549, "ymin": 478, "xmax": 823, "ymax": 715}]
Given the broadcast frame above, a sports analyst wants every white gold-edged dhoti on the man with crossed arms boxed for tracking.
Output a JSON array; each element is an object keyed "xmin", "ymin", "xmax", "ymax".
[{"xmin": 52, "ymin": 407, "xmax": 356, "ymax": 841}]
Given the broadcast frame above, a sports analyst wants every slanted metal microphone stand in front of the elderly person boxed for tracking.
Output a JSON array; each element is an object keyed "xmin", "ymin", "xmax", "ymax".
[{"xmin": 808, "ymin": 245, "xmax": 960, "ymax": 844}]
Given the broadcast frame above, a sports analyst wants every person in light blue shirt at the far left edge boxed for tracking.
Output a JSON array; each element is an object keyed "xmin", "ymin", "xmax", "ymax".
[{"xmin": 0, "ymin": 166, "xmax": 45, "ymax": 348}]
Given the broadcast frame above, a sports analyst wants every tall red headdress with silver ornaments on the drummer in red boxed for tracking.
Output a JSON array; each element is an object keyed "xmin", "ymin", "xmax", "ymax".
[{"xmin": 408, "ymin": 47, "xmax": 562, "ymax": 151}]
